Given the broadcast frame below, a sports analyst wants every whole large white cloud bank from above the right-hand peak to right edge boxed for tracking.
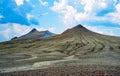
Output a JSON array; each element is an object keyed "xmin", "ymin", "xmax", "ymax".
[{"xmin": 51, "ymin": 0, "xmax": 120, "ymax": 25}]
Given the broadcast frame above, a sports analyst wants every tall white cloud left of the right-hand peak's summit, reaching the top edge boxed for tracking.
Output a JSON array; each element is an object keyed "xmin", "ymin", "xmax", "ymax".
[{"xmin": 51, "ymin": 0, "xmax": 77, "ymax": 24}]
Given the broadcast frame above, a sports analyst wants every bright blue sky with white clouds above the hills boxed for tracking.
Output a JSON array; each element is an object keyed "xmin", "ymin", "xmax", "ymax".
[{"xmin": 0, "ymin": 0, "xmax": 120, "ymax": 42}]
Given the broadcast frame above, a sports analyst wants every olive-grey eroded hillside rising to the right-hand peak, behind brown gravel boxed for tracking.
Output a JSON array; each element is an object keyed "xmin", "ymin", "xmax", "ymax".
[{"xmin": 0, "ymin": 25, "xmax": 120, "ymax": 75}]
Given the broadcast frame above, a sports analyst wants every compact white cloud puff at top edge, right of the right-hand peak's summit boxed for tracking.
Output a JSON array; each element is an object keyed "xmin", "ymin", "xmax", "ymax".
[{"xmin": 81, "ymin": 0, "xmax": 107, "ymax": 15}]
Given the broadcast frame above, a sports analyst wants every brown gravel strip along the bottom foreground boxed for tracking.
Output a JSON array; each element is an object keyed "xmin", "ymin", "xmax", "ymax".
[{"xmin": 0, "ymin": 65, "xmax": 120, "ymax": 76}]
